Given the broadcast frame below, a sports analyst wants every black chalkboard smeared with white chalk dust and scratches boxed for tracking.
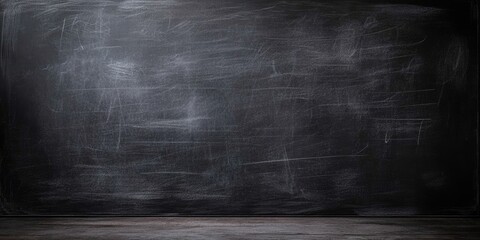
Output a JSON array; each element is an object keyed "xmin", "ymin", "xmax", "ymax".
[{"xmin": 0, "ymin": 0, "xmax": 479, "ymax": 215}]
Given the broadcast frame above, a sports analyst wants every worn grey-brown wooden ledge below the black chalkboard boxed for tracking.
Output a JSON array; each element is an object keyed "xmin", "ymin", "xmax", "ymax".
[{"xmin": 0, "ymin": 217, "xmax": 480, "ymax": 239}]
